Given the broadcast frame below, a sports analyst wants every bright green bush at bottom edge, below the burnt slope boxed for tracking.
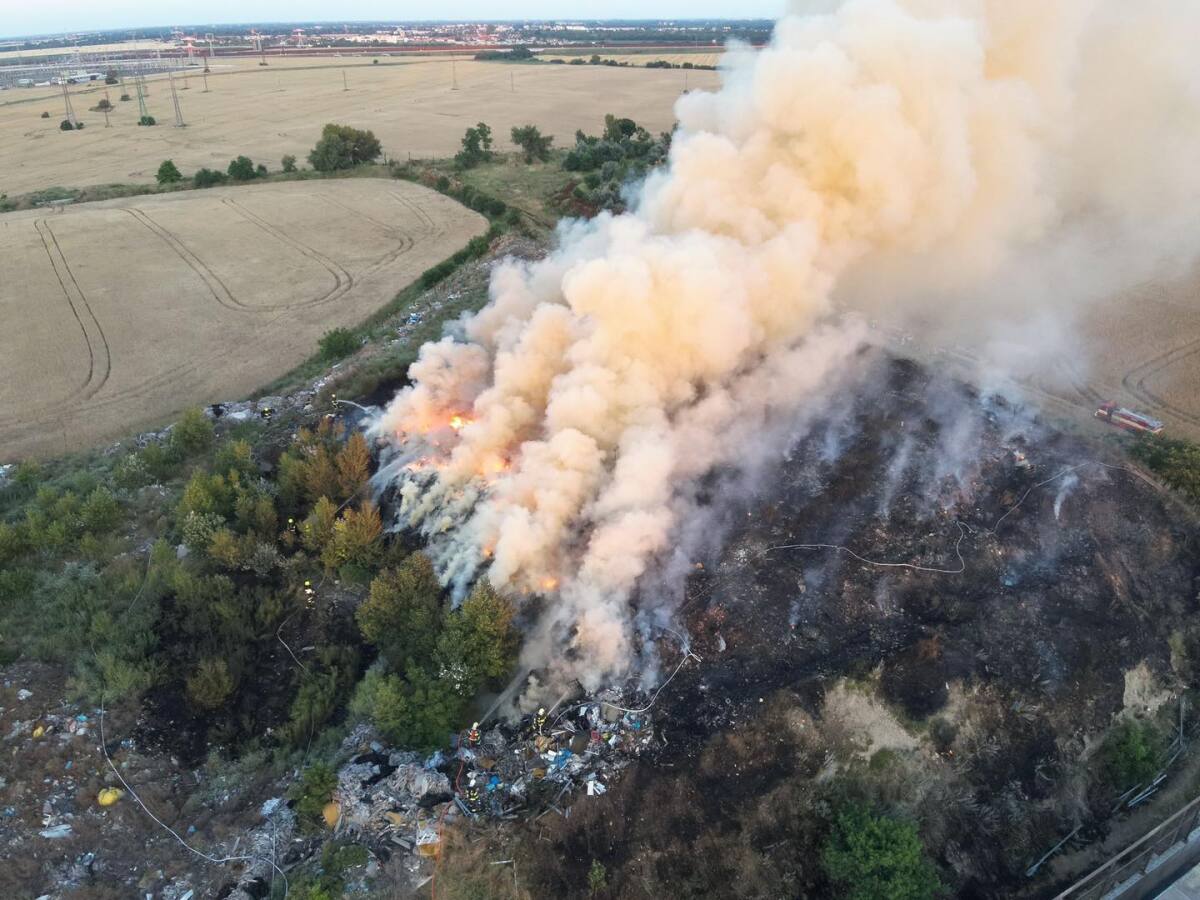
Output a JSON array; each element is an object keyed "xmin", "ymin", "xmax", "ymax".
[{"xmin": 821, "ymin": 805, "xmax": 942, "ymax": 900}]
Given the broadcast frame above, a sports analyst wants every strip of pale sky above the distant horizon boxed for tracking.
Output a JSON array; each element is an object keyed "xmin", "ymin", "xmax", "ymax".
[{"xmin": 0, "ymin": 0, "xmax": 785, "ymax": 36}]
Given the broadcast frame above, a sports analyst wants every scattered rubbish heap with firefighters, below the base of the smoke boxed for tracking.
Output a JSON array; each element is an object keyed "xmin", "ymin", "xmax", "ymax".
[{"xmin": 325, "ymin": 689, "xmax": 658, "ymax": 857}]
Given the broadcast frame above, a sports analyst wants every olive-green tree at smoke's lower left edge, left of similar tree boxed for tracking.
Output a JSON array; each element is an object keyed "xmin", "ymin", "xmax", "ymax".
[{"xmin": 354, "ymin": 553, "xmax": 442, "ymax": 672}]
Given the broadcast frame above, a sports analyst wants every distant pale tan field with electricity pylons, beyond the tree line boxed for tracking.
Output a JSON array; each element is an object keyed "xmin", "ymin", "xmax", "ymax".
[{"xmin": 0, "ymin": 56, "xmax": 718, "ymax": 196}]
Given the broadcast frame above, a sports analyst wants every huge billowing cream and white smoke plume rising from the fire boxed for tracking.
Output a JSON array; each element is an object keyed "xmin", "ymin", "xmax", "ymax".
[{"xmin": 374, "ymin": 0, "xmax": 1200, "ymax": 688}]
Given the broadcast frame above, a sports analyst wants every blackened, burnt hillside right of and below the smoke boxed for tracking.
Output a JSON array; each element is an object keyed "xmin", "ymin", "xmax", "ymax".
[{"xmin": 506, "ymin": 355, "xmax": 1200, "ymax": 898}]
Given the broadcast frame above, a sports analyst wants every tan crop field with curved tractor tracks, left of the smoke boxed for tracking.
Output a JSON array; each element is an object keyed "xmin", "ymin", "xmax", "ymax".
[{"xmin": 0, "ymin": 179, "xmax": 487, "ymax": 460}]
